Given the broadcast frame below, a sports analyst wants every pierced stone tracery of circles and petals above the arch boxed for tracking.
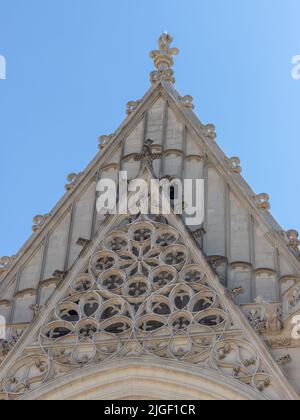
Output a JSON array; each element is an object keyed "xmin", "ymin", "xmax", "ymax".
[{"xmin": 3, "ymin": 217, "xmax": 278, "ymax": 397}]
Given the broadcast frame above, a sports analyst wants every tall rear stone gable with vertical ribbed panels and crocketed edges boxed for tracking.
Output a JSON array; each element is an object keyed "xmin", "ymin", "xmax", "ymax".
[{"xmin": 0, "ymin": 27, "xmax": 300, "ymax": 398}]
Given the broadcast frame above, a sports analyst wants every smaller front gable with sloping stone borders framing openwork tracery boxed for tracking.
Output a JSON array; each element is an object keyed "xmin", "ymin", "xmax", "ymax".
[{"xmin": 1, "ymin": 172, "xmax": 297, "ymax": 399}]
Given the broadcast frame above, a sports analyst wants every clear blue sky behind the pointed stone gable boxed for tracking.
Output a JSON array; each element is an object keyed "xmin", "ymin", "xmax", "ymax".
[{"xmin": 0, "ymin": 0, "xmax": 300, "ymax": 256}]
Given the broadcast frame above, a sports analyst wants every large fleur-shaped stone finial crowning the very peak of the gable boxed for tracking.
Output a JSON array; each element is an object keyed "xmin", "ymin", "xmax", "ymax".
[{"xmin": 150, "ymin": 32, "xmax": 179, "ymax": 83}]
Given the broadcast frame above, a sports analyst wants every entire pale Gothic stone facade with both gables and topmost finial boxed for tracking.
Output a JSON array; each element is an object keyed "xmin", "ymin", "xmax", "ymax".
[{"xmin": 0, "ymin": 34, "xmax": 300, "ymax": 400}]
